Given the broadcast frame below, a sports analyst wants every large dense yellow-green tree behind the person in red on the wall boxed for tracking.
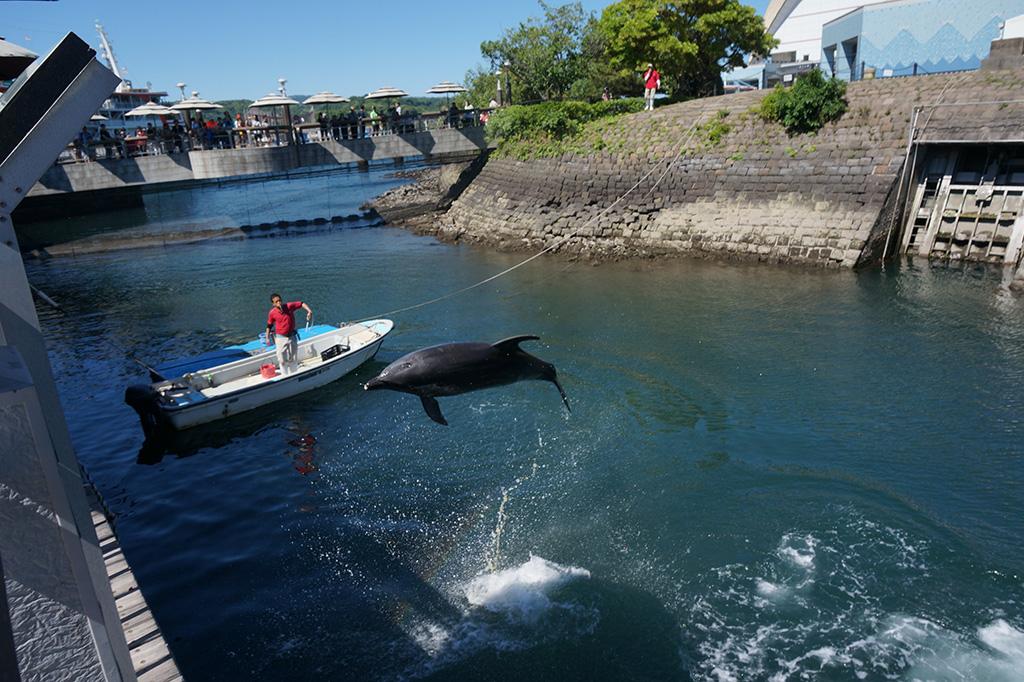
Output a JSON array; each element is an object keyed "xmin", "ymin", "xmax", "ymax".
[{"xmin": 598, "ymin": 0, "xmax": 776, "ymax": 97}]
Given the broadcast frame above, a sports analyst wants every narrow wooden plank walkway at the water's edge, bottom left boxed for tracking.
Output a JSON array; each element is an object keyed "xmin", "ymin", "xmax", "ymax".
[{"xmin": 92, "ymin": 506, "xmax": 183, "ymax": 682}]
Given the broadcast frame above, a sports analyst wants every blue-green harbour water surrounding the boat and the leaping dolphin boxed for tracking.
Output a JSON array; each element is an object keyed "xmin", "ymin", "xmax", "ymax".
[{"xmin": 29, "ymin": 166, "xmax": 1024, "ymax": 681}]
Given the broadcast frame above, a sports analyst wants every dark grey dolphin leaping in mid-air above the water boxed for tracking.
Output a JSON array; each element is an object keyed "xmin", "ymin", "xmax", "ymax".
[{"xmin": 364, "ymin": 336, "xmax": 571, "ymax": 426}]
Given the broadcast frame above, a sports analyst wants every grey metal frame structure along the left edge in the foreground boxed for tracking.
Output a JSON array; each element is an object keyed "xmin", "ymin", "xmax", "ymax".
[{"xmin": 0, "ymin": 33, "xmax": 135, "ymax": 680}]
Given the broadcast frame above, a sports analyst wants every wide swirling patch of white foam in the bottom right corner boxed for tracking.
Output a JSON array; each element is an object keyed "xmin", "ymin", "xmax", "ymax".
[{"xmin": 688, "ymin": 512, "xmax": 1024, "ymax": 682}]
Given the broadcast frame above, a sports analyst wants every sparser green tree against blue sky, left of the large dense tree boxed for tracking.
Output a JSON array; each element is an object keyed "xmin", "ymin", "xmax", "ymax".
[{"xmin": 480, "ymin": 0, "xmax": 593, "ymax": 101}]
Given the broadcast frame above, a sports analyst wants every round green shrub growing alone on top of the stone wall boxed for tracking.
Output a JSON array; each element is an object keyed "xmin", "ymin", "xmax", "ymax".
[{"xmin": 759, "ymin": 69, "xmax": 847, "ymax": 134}]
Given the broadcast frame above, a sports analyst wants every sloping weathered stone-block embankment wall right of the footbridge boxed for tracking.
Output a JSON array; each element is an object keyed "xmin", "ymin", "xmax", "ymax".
[{"xmin": 435, "ymin": 70, "xmax": 1024, "ymax": 266}]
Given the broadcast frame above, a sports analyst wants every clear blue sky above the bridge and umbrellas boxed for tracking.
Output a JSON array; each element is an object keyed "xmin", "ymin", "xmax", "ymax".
[{"xmin": 0, "ymin": 0, "xmax": 768, "ymax": 99}]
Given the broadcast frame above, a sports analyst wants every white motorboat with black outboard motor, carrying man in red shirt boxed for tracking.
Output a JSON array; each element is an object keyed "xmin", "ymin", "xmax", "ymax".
[{"xmin": 125, "ymin": 319, "xmax": 394, "ymax": 435}]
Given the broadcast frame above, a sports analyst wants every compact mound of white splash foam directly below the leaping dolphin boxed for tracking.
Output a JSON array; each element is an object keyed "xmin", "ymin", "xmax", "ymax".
[{"xmin": 464, "ymin": 554, "xmax": 590, "ymax": 624}]
